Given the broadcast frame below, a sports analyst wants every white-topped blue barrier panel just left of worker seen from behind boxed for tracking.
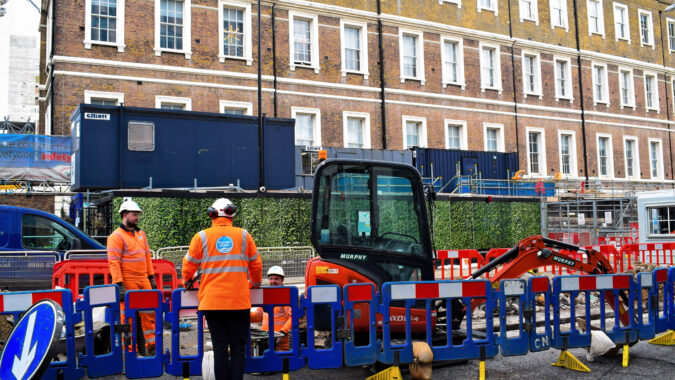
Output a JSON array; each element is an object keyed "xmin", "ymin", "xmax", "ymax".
[{"xmin": 166, "ymin": 289, "xmax": 204, "ymax": 376}]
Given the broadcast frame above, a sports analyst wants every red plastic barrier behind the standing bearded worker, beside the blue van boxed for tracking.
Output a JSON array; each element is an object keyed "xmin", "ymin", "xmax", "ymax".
[{"xmin": 52, "ymin": 259, "xmax": 179, "ymax": 299}]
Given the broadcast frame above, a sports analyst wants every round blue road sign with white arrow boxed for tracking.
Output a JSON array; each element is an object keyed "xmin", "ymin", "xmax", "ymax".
[{"xmin": 0, "ymin": 300, "xmax": 65, "ymax": 380}]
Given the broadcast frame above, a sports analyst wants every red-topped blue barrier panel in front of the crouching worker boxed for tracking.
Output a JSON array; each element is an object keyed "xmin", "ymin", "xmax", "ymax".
[{"xmin": 245, "ymin": 286, "xmax": 305, "ymax": 372}]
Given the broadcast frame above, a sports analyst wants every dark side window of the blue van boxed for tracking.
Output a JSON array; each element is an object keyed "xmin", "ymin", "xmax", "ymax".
[{"xmin": 21, "ymin": 214, "xmax": 76, "ymax": 251}]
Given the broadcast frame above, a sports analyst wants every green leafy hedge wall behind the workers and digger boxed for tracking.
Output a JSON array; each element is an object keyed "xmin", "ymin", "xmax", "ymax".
[{"xmin": 113, "ymin": 197, "xmax": 541, "ymax": 250}]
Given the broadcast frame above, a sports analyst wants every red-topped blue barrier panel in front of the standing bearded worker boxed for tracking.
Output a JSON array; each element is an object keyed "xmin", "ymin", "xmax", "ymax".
[{"xmin": 124, "ymin": 290, "xmax": 167, "ymax": 379}]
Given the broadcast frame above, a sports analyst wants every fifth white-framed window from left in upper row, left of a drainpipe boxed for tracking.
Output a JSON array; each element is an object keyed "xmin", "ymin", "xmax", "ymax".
[{"xmin": 340, "ymin": 20, "xmax": 368, "ymax": 79}]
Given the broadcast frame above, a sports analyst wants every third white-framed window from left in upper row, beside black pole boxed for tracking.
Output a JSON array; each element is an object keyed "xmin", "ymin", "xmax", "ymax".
[{"xmin": 218, "ymin": 0, "xmax": 253, "ymax": 65}]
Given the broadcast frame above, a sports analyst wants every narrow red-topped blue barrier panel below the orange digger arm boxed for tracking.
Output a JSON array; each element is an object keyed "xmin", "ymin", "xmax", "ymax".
[{"xmin": 528, "ymin": 277, "xmax": 553, "ymax": 352}]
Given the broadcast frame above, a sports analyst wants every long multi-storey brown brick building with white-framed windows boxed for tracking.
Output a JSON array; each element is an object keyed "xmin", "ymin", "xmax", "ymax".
[{"xmin": 40, "ymin": 0, "xmax": 675, "ymax": 183}]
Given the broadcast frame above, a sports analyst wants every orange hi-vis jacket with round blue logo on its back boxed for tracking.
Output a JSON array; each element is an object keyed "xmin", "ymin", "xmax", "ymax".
[{"xmin": 182, "ymin": 218, "xmax": 262, "ymax": 310}]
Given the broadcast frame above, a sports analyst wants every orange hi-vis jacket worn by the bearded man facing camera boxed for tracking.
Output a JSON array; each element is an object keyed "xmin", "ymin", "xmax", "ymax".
[{"xmin": 108, "ymin": 226, "xmax": 155, "ymax": 284}]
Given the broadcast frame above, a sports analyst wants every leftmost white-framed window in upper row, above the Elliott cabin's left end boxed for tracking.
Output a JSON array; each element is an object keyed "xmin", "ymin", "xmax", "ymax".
[{"xmin": 84, "ymin": 0, "xmax": 125, "ymax": 53}]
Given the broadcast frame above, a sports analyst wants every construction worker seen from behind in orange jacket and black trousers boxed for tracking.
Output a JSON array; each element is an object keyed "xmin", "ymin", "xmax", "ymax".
[{"xmin": 182, "ymin": 198, "xmax": 262, "ymax": 380}]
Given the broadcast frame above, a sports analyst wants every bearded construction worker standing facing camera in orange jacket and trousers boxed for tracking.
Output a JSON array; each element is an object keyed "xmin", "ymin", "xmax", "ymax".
[{"xmin": 108, "ymin": 198, "xmax": 157, "ymax": 356}]
